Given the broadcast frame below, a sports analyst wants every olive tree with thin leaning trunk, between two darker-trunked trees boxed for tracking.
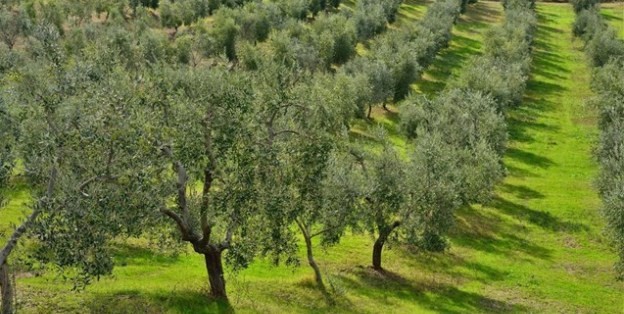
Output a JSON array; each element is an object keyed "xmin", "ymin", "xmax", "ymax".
[{"xmin": 251, "ymin": 62, "xmax": 357, "ymax": 294}]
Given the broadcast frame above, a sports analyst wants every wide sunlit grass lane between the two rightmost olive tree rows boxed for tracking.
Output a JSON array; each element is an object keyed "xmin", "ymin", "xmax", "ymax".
[{"xmin": 454, "ymin": 3, "xmax": 624, "ymax": 313}]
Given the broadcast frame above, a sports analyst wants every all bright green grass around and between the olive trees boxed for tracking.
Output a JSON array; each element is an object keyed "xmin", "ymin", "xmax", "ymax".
[{"xmin": 0, "ymin": 1, "xmax": 624, "ymax": 313}]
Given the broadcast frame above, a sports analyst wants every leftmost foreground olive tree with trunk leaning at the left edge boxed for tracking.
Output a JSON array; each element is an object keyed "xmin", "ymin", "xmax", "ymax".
[{"xmin": 0, "ymin": 24, "xmax": 156, "ymax": 313}]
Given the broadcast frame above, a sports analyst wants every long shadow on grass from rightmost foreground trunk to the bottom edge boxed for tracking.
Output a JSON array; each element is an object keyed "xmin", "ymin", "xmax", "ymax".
[{"xmin": 340, "ymin": 268, "xmax": 527, "ymax": 313}]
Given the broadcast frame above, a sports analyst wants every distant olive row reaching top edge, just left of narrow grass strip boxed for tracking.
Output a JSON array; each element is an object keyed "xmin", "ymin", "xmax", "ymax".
[{"xmin": 344, "ymin": 0, "xmax": 460, "ymax": 118}]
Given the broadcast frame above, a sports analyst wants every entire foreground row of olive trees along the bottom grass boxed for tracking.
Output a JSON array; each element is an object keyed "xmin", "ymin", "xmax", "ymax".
[{"xmin": 1, "ymin": 2, "xmax": 491, "ymax": 310}]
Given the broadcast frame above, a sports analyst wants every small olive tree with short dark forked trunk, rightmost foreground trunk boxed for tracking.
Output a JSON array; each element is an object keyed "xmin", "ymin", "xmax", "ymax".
[{"xmin": 348, "ymin": 130, "xmax": 461, "ymax": 271}]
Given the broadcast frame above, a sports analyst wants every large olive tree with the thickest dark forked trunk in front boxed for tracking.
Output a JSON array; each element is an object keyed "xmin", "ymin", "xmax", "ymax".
[{"xmin": 131, "ymin": 67, "xmax": 260, "ymax": 299}]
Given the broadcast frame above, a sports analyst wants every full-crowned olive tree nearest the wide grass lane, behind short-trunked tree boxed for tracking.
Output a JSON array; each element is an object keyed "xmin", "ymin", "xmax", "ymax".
[{"xmin": 394, "ymin": 90, "xmax": 507, "ymax": 251}]
